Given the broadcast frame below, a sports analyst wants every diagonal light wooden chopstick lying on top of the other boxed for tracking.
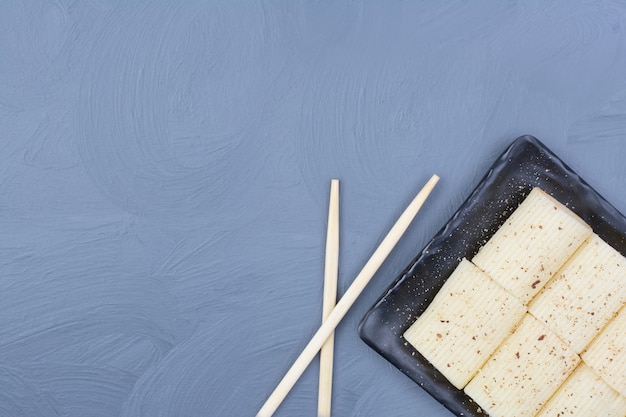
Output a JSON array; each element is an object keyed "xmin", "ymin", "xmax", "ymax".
[{"xmin": 257, "ymin": 175, "xmax": 439, "ymax": 417}]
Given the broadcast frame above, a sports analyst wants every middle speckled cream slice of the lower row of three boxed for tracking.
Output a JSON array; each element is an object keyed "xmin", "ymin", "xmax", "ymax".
[{"xmin": 465, "ymin": 314, "xmax": 580, "ymax": 417}]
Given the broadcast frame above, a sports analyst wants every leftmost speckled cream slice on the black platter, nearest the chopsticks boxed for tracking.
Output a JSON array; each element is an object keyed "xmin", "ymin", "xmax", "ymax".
[{"xmin": 404, "ymin": 259, "xmax": 526, "ymax": 389}]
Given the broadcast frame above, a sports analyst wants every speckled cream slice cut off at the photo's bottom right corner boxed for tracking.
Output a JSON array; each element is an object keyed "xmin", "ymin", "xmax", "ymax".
[{"xmin": 537, "ymin": 363, "xmax": 626, "ymax": 417}]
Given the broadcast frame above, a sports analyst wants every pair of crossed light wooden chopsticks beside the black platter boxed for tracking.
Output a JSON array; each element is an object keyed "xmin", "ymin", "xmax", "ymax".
[{"xmin": 256, "ymin": 175, "xmax": 439, "ymax": 417}]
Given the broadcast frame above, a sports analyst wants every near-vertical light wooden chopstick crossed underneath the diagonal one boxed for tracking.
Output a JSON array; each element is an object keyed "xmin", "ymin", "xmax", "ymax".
[{"xmin": 317, "ymin": 179, "xmax": 339, "ymax": 417}]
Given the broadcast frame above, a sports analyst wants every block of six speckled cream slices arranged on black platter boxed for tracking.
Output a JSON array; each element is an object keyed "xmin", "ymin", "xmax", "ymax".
[{"xmin": 404, "ymin": 188, "xmax": 626, "ymax": 417}]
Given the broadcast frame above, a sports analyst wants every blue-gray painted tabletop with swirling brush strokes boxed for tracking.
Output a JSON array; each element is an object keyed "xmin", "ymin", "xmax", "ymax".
[{"xmin": 0, "ymin": 0, "xmax": 626, "ymax": 417}]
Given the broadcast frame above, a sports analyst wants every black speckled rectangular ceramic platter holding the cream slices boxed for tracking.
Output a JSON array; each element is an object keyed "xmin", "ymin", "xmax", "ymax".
[{"xmin": 359, "ymin": 136, "xmax": 626, "ymax": 417}]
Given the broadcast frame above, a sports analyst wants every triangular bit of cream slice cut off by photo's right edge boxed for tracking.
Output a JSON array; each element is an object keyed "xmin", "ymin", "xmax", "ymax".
[{"xmin": 582, "ymin": 307, "xmax": 626, "ymax": 397}]
